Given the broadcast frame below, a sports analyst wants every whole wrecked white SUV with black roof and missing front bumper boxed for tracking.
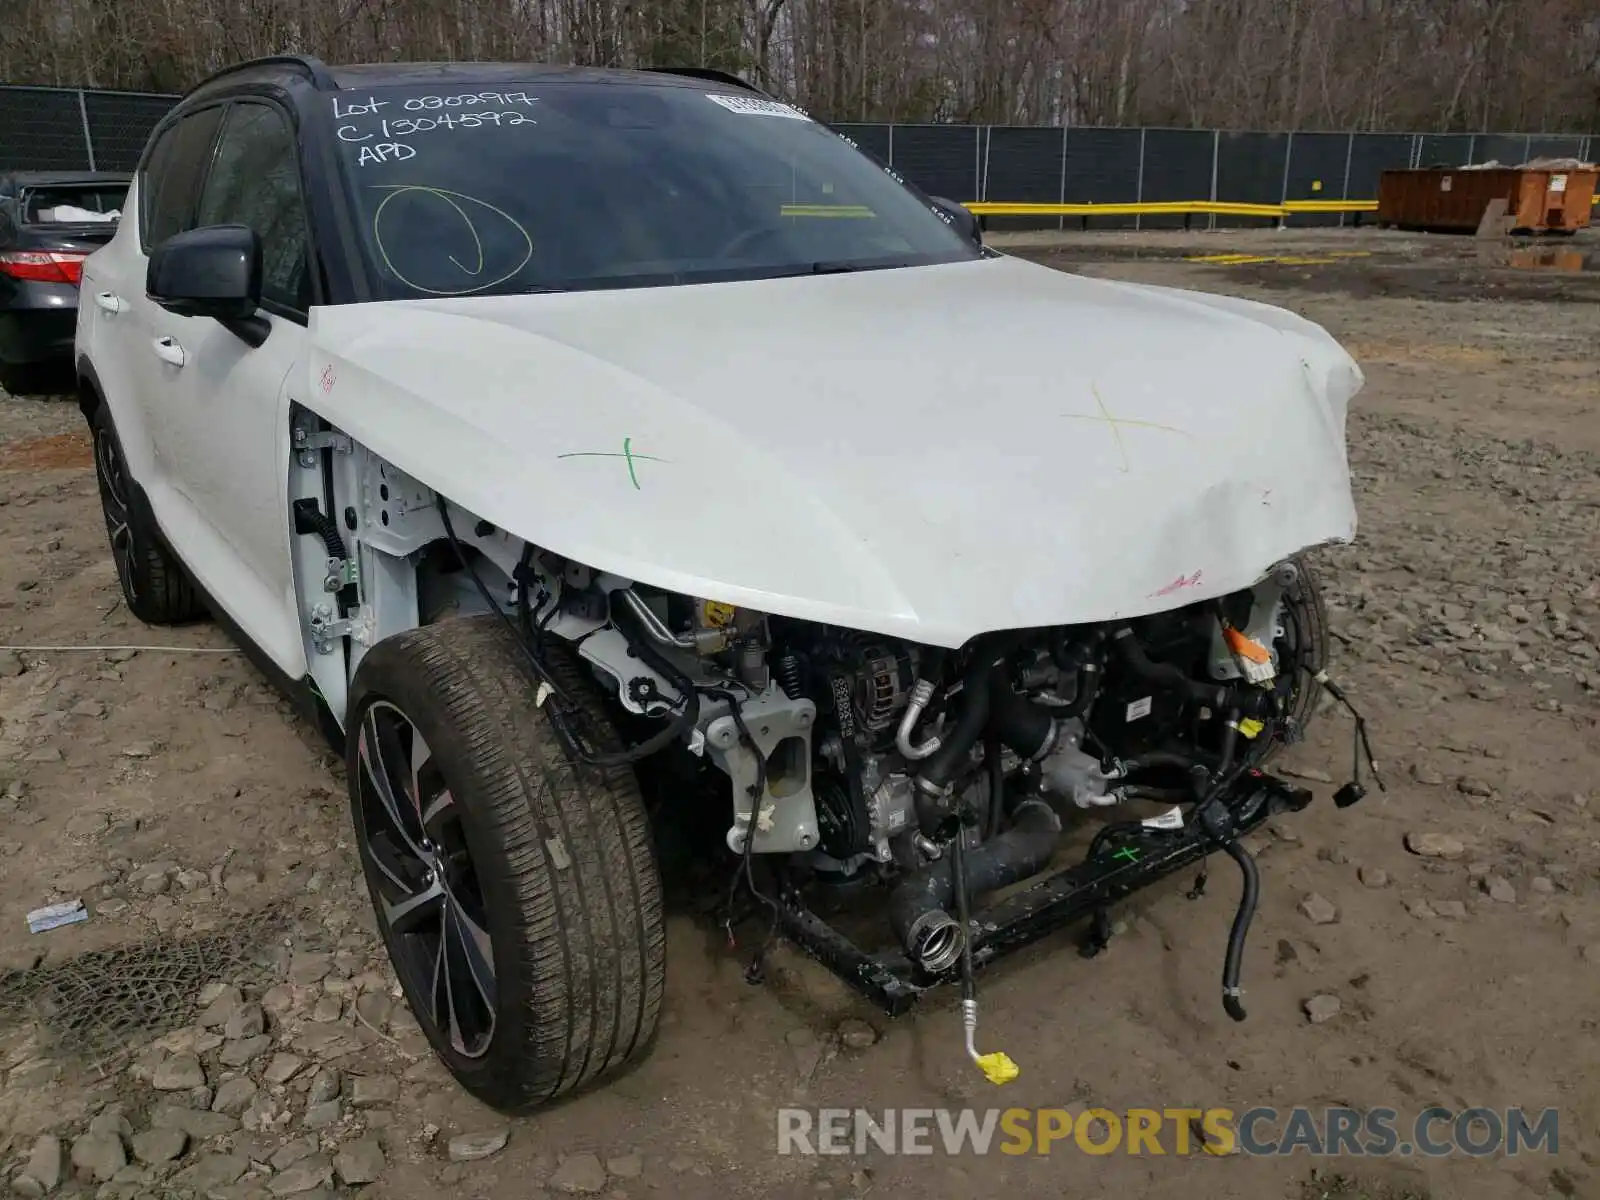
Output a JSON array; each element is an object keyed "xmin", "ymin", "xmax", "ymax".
[{"xmin": 78, "ymin": 59, "xmax": 1362, "ymax": 1109}]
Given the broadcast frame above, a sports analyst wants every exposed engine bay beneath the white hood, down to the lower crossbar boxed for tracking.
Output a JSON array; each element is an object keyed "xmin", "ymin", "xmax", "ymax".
[{"xmin": 502, "ymin": 550, "xmax": 1388, "ymax": 1011}]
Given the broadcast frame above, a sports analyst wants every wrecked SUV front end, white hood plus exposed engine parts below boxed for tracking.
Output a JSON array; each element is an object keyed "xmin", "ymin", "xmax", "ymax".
[{"xmin": 302, "ymin": 197, "xmax": 1376, "ymax": 1077}]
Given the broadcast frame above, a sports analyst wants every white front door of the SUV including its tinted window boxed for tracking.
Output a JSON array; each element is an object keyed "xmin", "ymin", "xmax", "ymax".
[{"xmin": 147, "ymin": 99, "xmax": 310, "ymax": 678}]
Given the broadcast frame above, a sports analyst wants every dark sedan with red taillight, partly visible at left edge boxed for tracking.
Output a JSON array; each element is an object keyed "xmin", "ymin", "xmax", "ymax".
[{"xmin": 0, "ymin": 171, "xmax": 128, "ymax": 392}]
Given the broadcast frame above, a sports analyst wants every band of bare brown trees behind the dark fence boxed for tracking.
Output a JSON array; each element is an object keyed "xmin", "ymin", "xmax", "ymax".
[{"xmin": 0, "ymin": 0, "xmax": 1600, "ymax": 133}]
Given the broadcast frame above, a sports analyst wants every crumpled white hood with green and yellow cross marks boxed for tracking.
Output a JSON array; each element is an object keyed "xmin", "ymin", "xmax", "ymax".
[{"xmin": 306, "ymin": 258, "xmax": 1362, "ymax": 646}]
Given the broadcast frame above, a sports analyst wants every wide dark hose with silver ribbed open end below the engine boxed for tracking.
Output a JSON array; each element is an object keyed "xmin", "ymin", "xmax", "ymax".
[{"xmin": 888, "ymin": 800, "xmax": 1061, "ymax": 971}]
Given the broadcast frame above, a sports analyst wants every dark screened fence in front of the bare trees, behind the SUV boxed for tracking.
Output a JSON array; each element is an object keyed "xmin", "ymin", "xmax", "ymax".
[{"xmin": 0, "ymin": 86, "xmax": 1600, "ymax": 229}]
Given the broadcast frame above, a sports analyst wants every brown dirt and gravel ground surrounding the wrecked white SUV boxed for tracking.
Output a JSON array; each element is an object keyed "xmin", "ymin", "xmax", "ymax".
[{"xmin": 0, "ymin": 230, "xmax": 1600, "ymax": 1200}]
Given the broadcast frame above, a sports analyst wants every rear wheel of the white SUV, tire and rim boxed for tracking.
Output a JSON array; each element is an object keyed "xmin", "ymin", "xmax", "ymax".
[{"xmin": 90, "ymin": 405, "xmax": 205, "ymax": 626}]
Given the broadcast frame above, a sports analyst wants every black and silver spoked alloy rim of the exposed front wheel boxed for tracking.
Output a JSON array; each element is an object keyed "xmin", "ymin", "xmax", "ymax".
[{"xmin": 357, "ymin": 701, "xmax": 498, "ymax": 1058}]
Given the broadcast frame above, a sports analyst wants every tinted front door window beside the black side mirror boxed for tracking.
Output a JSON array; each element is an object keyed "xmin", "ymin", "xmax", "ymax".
[{"xmin": 198, "ymin": 104, "xmax": 310, "ymax": 309}]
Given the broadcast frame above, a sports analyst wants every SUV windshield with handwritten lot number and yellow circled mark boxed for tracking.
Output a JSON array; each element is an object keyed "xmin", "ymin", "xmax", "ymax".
[{"xmin": 330, "ymin": 80, "xmax": 979, "ymax": 299}]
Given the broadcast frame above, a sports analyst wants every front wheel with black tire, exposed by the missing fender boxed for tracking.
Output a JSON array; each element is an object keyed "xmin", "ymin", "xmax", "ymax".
[{"xmin": 346, "ymin": 616, "xmax": 666, "ymax": 1112}]
